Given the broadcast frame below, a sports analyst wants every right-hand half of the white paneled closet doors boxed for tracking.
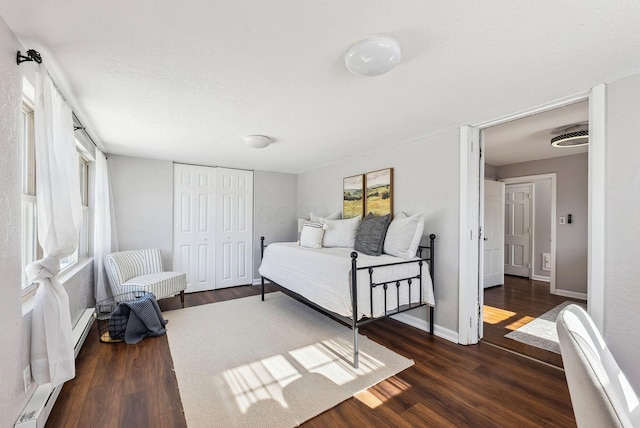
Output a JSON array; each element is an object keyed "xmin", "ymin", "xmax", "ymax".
[{"xmin": 216, "ymin": 168, "xmax": 253, "ymax": 288}]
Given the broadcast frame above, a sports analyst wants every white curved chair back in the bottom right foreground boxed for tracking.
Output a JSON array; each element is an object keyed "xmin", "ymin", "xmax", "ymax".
[{"xmin": 556, "ymin": 305, "xmax": 640, "ymax": 428}]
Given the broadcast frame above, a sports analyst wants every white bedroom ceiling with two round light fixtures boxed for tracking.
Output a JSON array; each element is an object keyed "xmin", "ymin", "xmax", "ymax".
[{"xmin": 0, "ymin": 0, "xmax": 640, "ymax": 173}]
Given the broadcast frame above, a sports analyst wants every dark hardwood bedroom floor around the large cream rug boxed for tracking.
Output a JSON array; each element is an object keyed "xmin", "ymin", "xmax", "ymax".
[{"xmin": 47, "ymin": 286, "xmax": 575, "ymax": 428}]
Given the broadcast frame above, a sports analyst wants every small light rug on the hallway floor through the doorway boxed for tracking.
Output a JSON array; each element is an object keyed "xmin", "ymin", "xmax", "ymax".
[{"xmin": 504, "ymin": 302, "xmax": 580, "ymax": 354}]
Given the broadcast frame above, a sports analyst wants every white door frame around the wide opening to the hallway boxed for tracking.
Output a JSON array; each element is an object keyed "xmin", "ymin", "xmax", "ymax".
[{"xmin": 458, "ymin": 85, "xmax": 606, "ymax": 344}]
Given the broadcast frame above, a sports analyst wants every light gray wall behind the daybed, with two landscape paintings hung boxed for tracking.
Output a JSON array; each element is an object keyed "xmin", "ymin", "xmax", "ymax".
[{"xmin": 298, "ymin": 129, "xmax": 460, "ymax": 332}]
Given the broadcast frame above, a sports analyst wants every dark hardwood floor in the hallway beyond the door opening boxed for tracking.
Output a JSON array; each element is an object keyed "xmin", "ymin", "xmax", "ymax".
[{"xmin": 483, "ymin": 275, "xmax": 584, "ymax": 367}]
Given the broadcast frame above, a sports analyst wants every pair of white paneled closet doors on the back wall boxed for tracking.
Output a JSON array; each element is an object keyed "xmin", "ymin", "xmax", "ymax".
[{"xmin": 173, "ymin": 164, "xmax": 253, "ymax": 292}]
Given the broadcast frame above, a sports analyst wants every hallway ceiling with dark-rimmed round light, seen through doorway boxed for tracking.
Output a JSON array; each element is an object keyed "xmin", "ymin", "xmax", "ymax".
[{"xmin": 483, "ymin": 101, "xmax": 589, "ymax": 166}]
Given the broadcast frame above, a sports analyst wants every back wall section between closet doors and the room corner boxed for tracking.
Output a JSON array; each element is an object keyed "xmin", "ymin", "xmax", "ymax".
[{"xmin": 253, "ymin": 171, "xmax": 298, "ymax": 283}]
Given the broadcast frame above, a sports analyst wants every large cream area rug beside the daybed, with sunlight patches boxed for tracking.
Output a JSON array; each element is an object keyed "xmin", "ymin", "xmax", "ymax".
[{"xmin": 163, "ymin": 293, "xmax": 413, "ymax": 428}]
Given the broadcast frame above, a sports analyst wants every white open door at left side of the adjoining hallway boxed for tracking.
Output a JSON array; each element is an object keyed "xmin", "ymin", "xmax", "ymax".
[{"xmin": 482, "ymin": 180, "xmax": 505, "ymax": 288}]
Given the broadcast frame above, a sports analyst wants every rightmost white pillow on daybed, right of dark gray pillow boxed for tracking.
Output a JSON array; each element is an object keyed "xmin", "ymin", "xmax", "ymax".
[{"xmin": 384, "ymin": 213, "xmax": 424, "ymax": 260}]
